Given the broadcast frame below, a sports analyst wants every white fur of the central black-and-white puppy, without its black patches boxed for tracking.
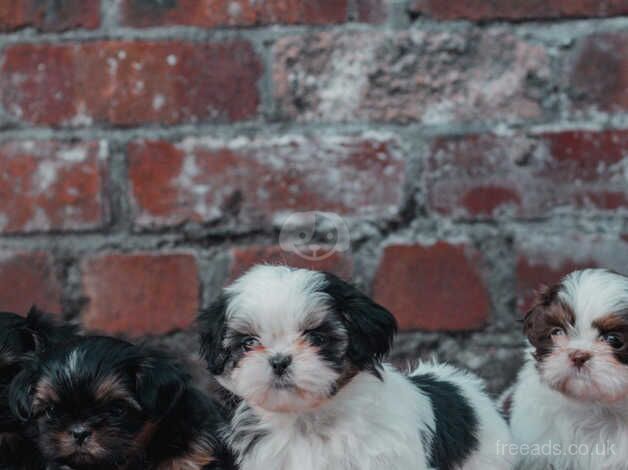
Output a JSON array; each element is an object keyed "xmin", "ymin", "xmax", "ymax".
[{"xmin": 218, "ymin": 266, "xmax": 511, "ymax": 470}]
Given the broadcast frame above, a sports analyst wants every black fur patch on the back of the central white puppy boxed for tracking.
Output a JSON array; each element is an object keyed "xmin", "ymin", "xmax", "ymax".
[{"xmin": 410, "ymin": 374, "xmax": 479, "ymax": 470}]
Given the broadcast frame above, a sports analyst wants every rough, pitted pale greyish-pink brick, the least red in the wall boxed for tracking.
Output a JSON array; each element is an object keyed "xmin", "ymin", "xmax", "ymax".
[{"xmin": 273, "ymin": 28, "xmax": 554, "ymax": 124}]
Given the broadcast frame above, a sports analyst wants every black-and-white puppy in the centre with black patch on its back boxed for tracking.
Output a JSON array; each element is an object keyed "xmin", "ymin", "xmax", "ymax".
[{"xmin": 200, "ymin": 266, "xmax": 509, "ymax": 470}]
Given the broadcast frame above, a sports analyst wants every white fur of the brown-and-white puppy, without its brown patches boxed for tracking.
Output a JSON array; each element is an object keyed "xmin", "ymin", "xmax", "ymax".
[{"xmin": 511, "ymin": 270, "xmax": 628, "ymax": 470}]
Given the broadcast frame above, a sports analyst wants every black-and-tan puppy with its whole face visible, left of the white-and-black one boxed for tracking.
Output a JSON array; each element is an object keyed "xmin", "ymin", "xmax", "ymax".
[{"xmin": 10, "ymin": 337, "xmax": 232, "ymax": 470}]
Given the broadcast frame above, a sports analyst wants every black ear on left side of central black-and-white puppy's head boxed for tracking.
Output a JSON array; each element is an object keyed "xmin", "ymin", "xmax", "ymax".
[{"xmin": 198, "ymin": 294, "xmax": 229, "ymax": 375}]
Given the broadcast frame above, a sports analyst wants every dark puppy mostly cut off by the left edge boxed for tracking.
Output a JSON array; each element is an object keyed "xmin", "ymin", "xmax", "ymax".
[{"xmin": 0, "ymin": 307, "xmax": 75, "ymax": 470}]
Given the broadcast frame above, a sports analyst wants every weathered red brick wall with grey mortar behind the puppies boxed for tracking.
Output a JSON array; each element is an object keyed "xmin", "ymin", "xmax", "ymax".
[{"xmin": 0, "ymin": 0, "xmax": 628, "ymax": 390}]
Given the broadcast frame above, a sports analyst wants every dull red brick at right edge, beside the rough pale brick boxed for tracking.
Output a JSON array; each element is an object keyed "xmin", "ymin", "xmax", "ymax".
[{"xmin": 566, "ymin": 33, "xmax": 628, "ymax": 112}]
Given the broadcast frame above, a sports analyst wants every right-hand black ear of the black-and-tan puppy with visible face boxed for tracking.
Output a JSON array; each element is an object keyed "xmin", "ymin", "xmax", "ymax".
[{"xmin": 136, "ymin": 351, "xmax": 190, "ymax": 418}]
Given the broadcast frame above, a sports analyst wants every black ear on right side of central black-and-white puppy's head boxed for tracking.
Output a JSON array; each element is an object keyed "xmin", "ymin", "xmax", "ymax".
[{"xmin": 322, "ymin": 273, "xmax": 397, "ymax": 371}]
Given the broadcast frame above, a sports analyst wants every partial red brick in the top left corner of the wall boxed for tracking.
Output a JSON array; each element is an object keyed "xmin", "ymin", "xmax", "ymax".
[{"xmin": 0, "ymin": 0, "xmax": 100, "ymax": 31}]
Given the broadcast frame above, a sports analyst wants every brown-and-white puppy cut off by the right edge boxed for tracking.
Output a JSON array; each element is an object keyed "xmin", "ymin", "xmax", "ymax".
[{"xmin": 504, "ymin": 269, "xmax": 628, "ymax": 470}]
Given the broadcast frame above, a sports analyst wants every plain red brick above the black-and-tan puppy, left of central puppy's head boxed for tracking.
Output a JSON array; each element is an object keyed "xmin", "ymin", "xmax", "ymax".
[{"xmin": 81, "ymin": 253, "xmax": 199, "ymax": 336}]
